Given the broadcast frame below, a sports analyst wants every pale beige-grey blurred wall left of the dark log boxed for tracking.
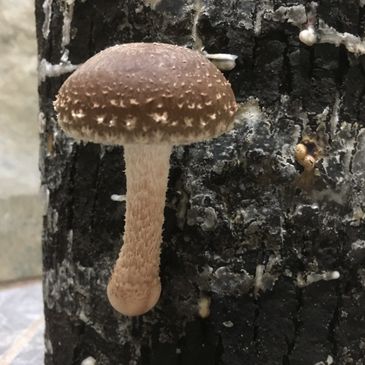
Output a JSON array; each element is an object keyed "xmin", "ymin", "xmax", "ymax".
[{"xmin": 0, "ymin": 0, "xmax": 41, "ymax": 281}]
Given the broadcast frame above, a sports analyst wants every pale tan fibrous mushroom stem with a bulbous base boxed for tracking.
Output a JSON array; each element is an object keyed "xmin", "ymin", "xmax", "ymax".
[{"xmin": 107, "ymin": 144, "xmax": 172, "ymax": 316}]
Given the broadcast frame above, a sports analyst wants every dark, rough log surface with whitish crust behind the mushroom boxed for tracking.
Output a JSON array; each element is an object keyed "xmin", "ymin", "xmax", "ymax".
[{"xmin": 36, "ymin": 0, "xmax": 365, "ymax": 365}]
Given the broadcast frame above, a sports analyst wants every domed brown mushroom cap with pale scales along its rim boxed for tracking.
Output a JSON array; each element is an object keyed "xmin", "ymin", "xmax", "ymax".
[{"xmin": 54, "ymin": 43, "xmax": 237, "ymax": 144}]
